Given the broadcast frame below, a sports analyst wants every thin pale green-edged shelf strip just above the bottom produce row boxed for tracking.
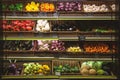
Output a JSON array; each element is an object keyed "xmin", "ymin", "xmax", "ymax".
[{"xmin": 3, "ymin": 55, "xmax": 115, "ymax": 62}]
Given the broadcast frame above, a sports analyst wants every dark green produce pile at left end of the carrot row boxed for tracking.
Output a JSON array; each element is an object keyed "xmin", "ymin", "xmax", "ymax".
[{"xmin": 3, "ymin": 40, "xmax": 33, "ymax": 51}]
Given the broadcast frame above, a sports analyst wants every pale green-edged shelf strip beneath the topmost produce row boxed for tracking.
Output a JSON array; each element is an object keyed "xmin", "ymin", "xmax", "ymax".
[{"xmin": 3, "ymin": 16, "xmax": 116, "ymax": 20}]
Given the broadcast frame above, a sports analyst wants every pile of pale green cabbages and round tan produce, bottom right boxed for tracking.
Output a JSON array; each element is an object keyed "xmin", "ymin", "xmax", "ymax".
[{"xmin": 80, "ymin": 61, "xmax": 111, "ymax": 75}]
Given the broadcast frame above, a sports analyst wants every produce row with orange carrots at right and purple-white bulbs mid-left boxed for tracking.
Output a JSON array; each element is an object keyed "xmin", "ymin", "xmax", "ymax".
[{"xmin": 3, "ymin": 40, "xmax": 116, "ymax": 54}]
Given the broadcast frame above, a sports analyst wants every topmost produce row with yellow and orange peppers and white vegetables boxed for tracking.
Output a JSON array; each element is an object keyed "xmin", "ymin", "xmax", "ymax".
[{"xmin": 1, "ymin": 1, "xmax": 116, "ymax": 12}]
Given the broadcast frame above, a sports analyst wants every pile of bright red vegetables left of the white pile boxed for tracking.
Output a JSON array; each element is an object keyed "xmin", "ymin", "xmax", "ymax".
[{"xmin": 2, "ymin": 20, "xmax": 35, "ymax": 31}]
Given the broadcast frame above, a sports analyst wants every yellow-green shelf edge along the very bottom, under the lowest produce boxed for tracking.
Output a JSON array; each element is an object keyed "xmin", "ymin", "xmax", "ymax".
[{"xmin": 2, "ymin": 75, "xmax": 117, "ymax": 79}]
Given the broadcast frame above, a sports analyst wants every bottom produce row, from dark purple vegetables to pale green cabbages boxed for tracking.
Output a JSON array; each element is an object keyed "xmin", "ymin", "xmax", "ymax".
[{"xmin": 4, "ymin": 60, "xmax": 113, "ymax": 76}]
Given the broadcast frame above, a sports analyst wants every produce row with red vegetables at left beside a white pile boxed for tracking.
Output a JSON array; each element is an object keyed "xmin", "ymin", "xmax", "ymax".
[{"xmin": 0, "ymin": 19, "xmax": 115, "ymax": 33}]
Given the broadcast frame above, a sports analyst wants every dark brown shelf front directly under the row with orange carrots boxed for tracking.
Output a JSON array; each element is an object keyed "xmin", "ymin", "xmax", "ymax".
[{"xmin": 4, "ymin": 51, "xmax": 116, "ymax": 58}]
